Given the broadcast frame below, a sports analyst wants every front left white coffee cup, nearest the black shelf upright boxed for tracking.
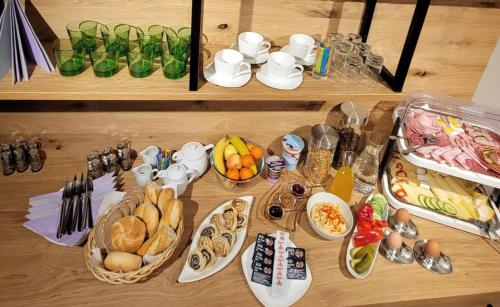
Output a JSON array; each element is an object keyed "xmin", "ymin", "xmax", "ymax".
[{"xmin": 215, "ymin": 49, "xmax": 251, "ymax": 79}]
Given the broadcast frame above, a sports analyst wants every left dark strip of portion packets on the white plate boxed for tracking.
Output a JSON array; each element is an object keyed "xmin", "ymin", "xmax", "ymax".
[{"xmin": 252, "ymin": 233, "xmax": 275, "ymax": 287}]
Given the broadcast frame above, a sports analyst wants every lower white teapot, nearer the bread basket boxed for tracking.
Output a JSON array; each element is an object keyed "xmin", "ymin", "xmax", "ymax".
[{"xmin": 153, "ymin": 163, "xmax": 197, "ymax": 196}]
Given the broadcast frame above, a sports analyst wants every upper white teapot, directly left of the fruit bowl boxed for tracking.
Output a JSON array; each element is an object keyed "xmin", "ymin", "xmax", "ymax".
[{"xmin": 172, "ymin": 142, "xmax": 214, "ymax": 177}]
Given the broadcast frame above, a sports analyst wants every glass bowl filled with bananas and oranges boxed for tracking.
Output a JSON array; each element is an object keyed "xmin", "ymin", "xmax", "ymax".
[{"xmin": 210, "ymin": 135, "xmax": 264, "ymax": 192}]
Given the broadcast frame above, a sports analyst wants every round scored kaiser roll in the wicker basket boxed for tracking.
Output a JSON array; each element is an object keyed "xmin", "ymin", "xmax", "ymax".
[{"xmin": 111, "ymin": 216, "xmax": 146, "ymax": 253}]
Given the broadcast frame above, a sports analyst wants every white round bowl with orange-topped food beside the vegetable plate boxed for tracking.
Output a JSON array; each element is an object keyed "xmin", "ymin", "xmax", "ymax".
[{"xmin": 307, "ymin": 192, "xmax": 354, "ymax": 240}]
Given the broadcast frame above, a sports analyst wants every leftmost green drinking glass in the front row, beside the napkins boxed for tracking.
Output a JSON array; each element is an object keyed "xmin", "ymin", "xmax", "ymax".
[{"xmin": 52, "ymin": 39, "xmax": 85, "ymax": 77}]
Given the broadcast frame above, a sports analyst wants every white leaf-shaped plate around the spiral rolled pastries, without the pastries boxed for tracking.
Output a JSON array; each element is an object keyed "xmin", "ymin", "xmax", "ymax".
[{"xmin": 177, "ymin": 196, "xmax": 253, "ymax": 282}]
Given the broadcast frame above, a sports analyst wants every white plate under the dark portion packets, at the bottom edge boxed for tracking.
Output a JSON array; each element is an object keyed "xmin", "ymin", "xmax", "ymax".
[{"xmin": 241, "ymin": 234, "xmax": 312, "ymax": 307}]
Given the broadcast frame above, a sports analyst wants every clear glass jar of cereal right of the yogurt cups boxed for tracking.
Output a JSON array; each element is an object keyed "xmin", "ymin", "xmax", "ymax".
[{"xmin": 304, "ymin": 124, "xmax": 339, "ymax": 184}]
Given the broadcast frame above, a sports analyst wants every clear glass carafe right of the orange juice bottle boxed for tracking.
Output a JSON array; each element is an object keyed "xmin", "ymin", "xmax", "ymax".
[{"xmin": 353, "ymin": 136, "xmax": 382, "ymax": 194}]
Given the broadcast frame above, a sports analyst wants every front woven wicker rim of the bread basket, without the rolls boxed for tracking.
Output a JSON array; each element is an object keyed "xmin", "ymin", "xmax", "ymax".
[{"xmin": 85, "ymin": 201, "xmax": 184, "ymax": 284}]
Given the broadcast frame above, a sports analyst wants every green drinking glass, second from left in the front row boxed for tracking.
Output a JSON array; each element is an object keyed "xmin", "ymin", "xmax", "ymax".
[{"xmin": 90, "ymin": 39, "xmax": 120, "ymax": 78}]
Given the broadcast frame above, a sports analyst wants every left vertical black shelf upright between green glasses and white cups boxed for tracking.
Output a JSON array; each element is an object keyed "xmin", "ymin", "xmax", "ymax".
[{"xmin": 189, "ymin": 0, "xmax": 203, "ymax": 91}]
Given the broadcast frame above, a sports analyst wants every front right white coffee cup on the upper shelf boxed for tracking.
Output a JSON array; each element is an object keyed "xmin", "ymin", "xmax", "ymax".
[{"xmin": 265, "ymin": 51, "xmax": 304, "ymax": 80}]
